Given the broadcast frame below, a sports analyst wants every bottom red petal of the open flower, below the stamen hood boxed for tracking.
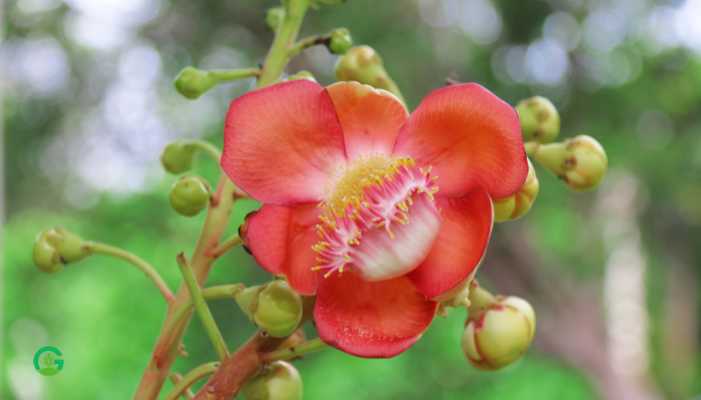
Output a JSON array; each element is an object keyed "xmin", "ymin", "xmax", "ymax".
[{"xmin": 314, "ymin": 271, "xmax": 436, "ymax": 358}]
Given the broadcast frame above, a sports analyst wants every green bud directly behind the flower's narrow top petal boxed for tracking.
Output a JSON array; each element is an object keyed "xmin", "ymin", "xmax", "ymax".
[{"xmin": 336, "ymin": 46, "xmax": 403, "ymax": 101}]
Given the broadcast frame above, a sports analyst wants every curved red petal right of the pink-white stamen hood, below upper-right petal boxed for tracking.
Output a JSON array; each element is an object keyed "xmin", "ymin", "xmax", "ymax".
[{"xmin": 408, "ymin": 189, "xmax": 493, "ymax": 298}]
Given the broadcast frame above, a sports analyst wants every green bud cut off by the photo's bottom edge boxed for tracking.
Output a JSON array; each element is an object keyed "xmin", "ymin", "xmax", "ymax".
[{"xmin": 241, "ymin": 361, "xmax": 302, "ymax": 400}]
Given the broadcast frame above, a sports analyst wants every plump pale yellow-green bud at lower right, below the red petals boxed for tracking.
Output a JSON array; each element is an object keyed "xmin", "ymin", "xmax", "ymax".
[{"xmin": 461, "ymin": 296, "xmax": 535, "ymax": 370}]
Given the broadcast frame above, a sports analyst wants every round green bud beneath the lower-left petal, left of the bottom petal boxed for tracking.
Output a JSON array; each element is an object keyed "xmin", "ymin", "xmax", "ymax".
[{"xmin": 236, "ymin": 280, "xmax": 303, "ymax": 337}]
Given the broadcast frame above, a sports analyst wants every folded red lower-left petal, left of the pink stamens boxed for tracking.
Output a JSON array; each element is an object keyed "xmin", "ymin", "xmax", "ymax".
[{"xmin": 242, "ymin": 204, "xmax": 319, "ymax": 295}]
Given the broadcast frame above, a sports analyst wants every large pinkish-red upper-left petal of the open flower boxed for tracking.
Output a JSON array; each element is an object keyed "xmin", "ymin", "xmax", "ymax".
[{"xmin": 221, "ymin": 79, "xmax": 345, "ymax": 204}]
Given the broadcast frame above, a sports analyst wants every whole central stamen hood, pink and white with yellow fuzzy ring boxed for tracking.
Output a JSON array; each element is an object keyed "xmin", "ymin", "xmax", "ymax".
[{"xmin": 313, "ymin": 157, "xmax": 440, "ymax": 281}]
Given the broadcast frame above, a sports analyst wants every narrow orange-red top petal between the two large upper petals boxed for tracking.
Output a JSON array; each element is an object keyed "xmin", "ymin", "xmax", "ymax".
[{"xmin": 326, "ymin": 82, "xmax": 409, "ymax": 160}]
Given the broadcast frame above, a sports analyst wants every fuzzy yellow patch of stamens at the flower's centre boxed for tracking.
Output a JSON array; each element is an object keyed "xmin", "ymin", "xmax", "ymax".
[{"xmin": 321, "ymin": 156, "xmax": 414, "ymax": 219}]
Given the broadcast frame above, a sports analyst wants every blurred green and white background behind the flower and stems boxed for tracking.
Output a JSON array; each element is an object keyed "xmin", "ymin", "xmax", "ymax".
[{"xmin": 0, "ymin": 0, "xmax": 701, "ymax": 400}]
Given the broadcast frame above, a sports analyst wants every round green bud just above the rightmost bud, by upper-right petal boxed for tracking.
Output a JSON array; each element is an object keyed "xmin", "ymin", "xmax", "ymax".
[{"xmin": 516, "ymin": 96, "xmax": 560, "ymax": 143}]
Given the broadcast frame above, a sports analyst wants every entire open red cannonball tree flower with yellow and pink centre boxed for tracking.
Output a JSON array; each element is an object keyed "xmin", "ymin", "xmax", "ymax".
[{"xmin": 221, "ymin": 80, "xmax": 528, "ymax": 357}]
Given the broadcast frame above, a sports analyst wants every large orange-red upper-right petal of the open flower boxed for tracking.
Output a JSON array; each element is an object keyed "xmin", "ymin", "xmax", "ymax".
[{"xmin": 394, "ymin": 83, "xmax": 528, "ymax": 198}]
